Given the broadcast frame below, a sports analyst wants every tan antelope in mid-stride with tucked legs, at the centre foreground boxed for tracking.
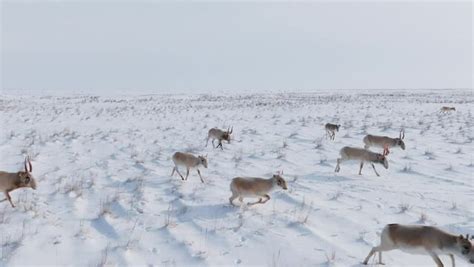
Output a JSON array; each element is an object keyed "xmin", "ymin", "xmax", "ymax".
[{"xmin": 229, "ymin": 172, "xmax": 288, "ymax": 206}]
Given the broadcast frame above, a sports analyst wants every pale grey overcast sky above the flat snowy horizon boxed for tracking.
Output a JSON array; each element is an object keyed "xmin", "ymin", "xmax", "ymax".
[{"xmin": 1, "ymin": 1, "xmax": 473, "ymax": 93}]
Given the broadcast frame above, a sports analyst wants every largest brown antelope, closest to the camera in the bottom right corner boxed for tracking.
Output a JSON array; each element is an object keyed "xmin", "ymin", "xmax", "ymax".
[{"xmin": 364, "ymin": 224, "xmax": 474, "ymax": 267}]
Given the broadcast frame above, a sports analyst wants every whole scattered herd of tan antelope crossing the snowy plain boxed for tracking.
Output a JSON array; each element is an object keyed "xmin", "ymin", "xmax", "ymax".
[{"xmin": 0, "ymin": 107, "xmax": 468, "ymax": 267}]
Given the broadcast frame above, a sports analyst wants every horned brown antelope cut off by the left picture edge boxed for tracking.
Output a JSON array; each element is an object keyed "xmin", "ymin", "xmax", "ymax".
[{"xmin": 0, "ymin": 157, "xmax": 36, "ymax": 208}]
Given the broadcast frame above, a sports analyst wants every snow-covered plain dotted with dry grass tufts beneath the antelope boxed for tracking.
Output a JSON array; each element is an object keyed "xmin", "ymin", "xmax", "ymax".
[{"xmin": 0, "ymin": 91, "xmax": 474, "ymax": 266}]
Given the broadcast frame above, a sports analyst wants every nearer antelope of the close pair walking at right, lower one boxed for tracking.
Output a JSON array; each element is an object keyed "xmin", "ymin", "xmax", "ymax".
[{"xmin": 334, "ymin": 146, "xmax": 388, "ymax": 176}]
